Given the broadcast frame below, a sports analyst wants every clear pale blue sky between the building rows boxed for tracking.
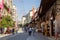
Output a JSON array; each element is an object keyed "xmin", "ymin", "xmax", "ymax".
[{"xmin": 13, "ymin": 0, "xmax": 41, "ymax": 20}]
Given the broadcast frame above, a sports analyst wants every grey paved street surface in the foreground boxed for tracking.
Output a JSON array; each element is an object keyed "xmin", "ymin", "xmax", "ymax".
[{"xmin": 0, "ymin": 33, "xmax": 51, "ymax": 40}]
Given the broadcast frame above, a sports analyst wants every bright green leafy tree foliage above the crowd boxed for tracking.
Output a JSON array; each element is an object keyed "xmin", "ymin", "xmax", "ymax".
[{"xmin": 0, "ymin": 16, "xmax": 14, "ymax": 27}]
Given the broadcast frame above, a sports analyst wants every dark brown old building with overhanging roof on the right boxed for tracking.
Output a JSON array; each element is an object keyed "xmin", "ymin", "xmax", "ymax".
[{"xmin": 35, "ymin": 0, "xmax": 60, "ymax": 36}]
